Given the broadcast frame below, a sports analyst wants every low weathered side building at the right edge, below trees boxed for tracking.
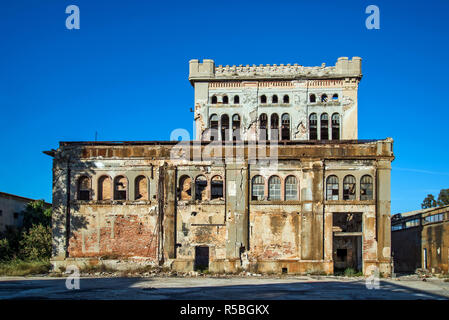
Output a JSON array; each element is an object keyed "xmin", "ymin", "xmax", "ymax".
[{"xmin": 391, "ymin": 205, "xmax": 449, "ymax": 274}]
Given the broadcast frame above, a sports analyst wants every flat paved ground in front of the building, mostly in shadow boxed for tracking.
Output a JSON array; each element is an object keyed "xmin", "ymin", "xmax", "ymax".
[{"xmin": 0, "ymin": 276, "xmax": 449, "ymax": 300}]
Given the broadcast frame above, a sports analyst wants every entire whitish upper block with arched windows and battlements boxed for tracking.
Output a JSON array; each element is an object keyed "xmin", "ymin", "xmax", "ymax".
[{"xmin": 189, "ymin": 57, "xmax": 362, "ymax": 140}]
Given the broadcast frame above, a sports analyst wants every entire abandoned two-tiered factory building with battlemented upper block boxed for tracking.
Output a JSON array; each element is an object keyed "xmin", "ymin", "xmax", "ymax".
[{"xmin": 45, "ymin": 57, "xmax": 394, "ymax": 275}]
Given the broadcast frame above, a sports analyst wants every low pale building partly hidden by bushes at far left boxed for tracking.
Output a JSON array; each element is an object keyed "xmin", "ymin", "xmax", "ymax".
[{"xmin": 0, "ymin": 192, "xmax": 51, "ymax": 233}]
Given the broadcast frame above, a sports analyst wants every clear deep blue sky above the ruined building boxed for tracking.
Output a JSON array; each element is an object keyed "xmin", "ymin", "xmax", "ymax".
[{"xmin": 0, "ymin": 0, "xmax": 449, "ymax": 213}]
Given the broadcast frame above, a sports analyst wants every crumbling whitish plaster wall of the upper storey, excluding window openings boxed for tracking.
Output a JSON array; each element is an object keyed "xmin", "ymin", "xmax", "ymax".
[{"xmin": 189, "ymin": 57, "xmax": 362, "ymax": 140}]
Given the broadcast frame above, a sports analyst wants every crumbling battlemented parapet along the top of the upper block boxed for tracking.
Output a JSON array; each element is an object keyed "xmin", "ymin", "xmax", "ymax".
[{"xmin": 189, "ymin": 57, "xmax": 362, "ymax": 81}]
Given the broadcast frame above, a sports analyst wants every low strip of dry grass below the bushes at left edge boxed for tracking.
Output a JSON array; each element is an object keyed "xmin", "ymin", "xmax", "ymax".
[{"xmin": 0, "ymin": 260, "xmax": 51, "ymax": 276}]
